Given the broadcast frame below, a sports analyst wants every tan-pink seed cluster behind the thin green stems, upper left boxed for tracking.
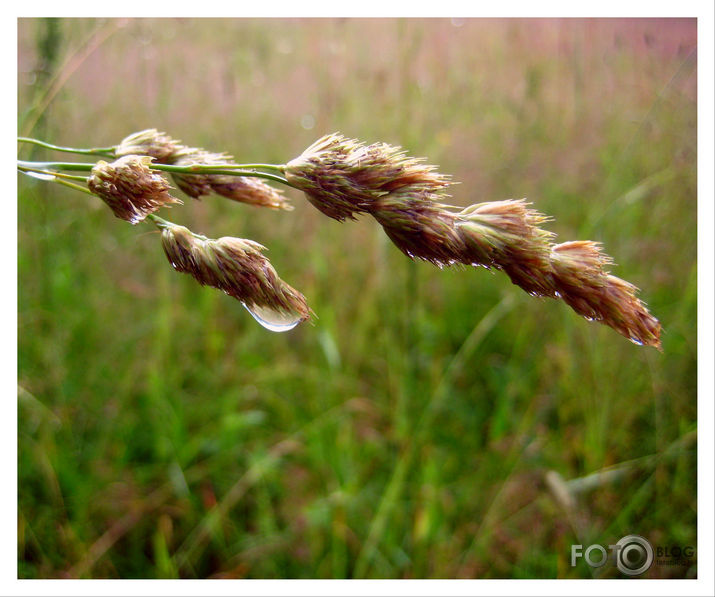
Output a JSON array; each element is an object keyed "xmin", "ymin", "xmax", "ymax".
[{"xmin": 115, "ymin": 129, "xmax": 293, "ymax": 210}]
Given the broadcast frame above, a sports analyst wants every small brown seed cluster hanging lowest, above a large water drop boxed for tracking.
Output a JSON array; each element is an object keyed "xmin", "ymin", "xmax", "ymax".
[{"xmin": 157, "ymin": 220, "xmax": 310, "ymax": 321}]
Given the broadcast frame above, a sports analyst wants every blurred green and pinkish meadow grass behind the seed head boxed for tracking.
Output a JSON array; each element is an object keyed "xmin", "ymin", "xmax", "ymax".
[{"xmin": 18, "ymin": 19, "xmax": 697, "ymax": 578}]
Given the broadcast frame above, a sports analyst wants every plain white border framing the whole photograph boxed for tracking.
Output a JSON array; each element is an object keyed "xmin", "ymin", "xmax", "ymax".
[{"xmin": 7, "ymin": 0, "xmax": 715, "ymax": 597}]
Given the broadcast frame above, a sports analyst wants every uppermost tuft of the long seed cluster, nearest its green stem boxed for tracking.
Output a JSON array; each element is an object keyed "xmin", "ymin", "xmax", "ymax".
[{"xmin": 284, "ymin": 133, "xmax": 450, "ymax": 221}]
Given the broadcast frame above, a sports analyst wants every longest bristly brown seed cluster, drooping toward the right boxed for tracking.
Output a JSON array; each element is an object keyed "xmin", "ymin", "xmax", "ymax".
[{"xmin": 284, "ymin": 134, "xmax": 660, "ymax": 348}]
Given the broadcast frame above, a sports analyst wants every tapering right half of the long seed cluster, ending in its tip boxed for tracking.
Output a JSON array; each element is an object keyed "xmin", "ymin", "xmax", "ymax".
[{"xmin": 430, "ymin": 200, "xmax": 661, "ymax": 349}]
